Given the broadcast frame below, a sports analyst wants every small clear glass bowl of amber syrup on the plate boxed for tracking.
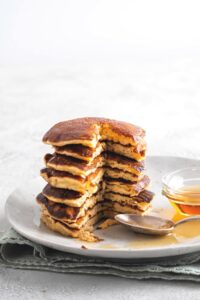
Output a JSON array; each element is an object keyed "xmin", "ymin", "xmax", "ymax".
[{"xmin": 162, "ymin": 168, "xmax": 200, "ymax": 216}]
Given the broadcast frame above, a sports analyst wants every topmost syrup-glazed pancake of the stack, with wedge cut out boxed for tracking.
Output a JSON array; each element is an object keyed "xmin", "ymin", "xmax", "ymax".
[{"xmin": 43, "ymin": 118, "xmax": 145, "ymax": 148}]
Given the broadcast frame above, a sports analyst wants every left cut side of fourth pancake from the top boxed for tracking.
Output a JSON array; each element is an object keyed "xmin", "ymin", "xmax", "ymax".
[{"xmin": 40, "ymin": 168, "xmax": 104, "ymax": 193}]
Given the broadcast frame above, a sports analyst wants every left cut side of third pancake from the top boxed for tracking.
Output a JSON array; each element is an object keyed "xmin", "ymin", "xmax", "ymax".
[{"xmin": 44, "ymin": 153, "xmax": 104, "ymax": 177}]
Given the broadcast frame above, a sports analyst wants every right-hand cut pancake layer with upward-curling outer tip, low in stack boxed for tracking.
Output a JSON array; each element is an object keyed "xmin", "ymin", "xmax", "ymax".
[{"xmin": 104, "ymin": 175, "xmax": 150, "ymax": 196}]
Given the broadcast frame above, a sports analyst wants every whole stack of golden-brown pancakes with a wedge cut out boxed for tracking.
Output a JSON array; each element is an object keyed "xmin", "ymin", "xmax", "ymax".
[{"xmin": 37, "ymin": 118, "xmax": 153, "ymax": 241}]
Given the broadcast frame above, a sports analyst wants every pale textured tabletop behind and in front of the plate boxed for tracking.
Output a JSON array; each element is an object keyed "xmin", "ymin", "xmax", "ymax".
[{"xmin": 0, "ymin": 63, "xmax": 200, "ymax": 300}]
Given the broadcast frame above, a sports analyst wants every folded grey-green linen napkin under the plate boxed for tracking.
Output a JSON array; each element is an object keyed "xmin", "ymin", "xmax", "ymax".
[{"xmin": 0, "ymin": 229, "xmax": 200, "ymax": 282}]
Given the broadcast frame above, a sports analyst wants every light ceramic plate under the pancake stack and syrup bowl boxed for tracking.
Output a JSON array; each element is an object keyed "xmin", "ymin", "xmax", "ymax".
[{"xmin": 6, "ymin": 156, "xmax": 200, "ymax": 259}]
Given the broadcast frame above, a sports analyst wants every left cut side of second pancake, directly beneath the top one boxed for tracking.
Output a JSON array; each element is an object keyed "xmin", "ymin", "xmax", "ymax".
[{"xmin": 54, "ymin": 142, "xmax": 105, "ymax": 162}]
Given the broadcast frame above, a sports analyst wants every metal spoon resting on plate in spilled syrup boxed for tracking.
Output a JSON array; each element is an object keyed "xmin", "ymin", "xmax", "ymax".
[{"xmin": 115, "ymin": 214, "xmax": 200, "ymax": 235}]
